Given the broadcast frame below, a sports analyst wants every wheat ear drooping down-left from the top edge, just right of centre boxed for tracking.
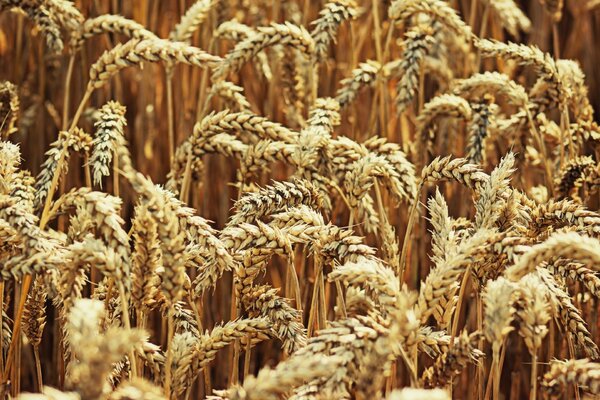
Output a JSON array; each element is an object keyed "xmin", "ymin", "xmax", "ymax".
[{"xmin": 310, "ymin": 0, "xmax": 359, "ymax": 61}]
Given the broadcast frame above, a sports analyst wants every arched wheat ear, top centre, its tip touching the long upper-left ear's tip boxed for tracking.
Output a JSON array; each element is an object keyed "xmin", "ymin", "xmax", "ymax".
[{"xmin": 213, "ymin": 22, "xmax": 315, "ymax": 80}]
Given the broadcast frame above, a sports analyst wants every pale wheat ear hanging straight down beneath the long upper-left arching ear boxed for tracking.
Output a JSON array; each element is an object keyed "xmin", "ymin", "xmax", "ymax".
[{"xmin": 90, "ymin": 101, "xmax": 127, "ymax": 187}]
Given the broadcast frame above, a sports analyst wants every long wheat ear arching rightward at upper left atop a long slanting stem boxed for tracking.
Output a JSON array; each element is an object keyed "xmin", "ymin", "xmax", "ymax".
[{"xmin": 87, "ymin": 39, "xmax": 221, "ymax": 92}]
